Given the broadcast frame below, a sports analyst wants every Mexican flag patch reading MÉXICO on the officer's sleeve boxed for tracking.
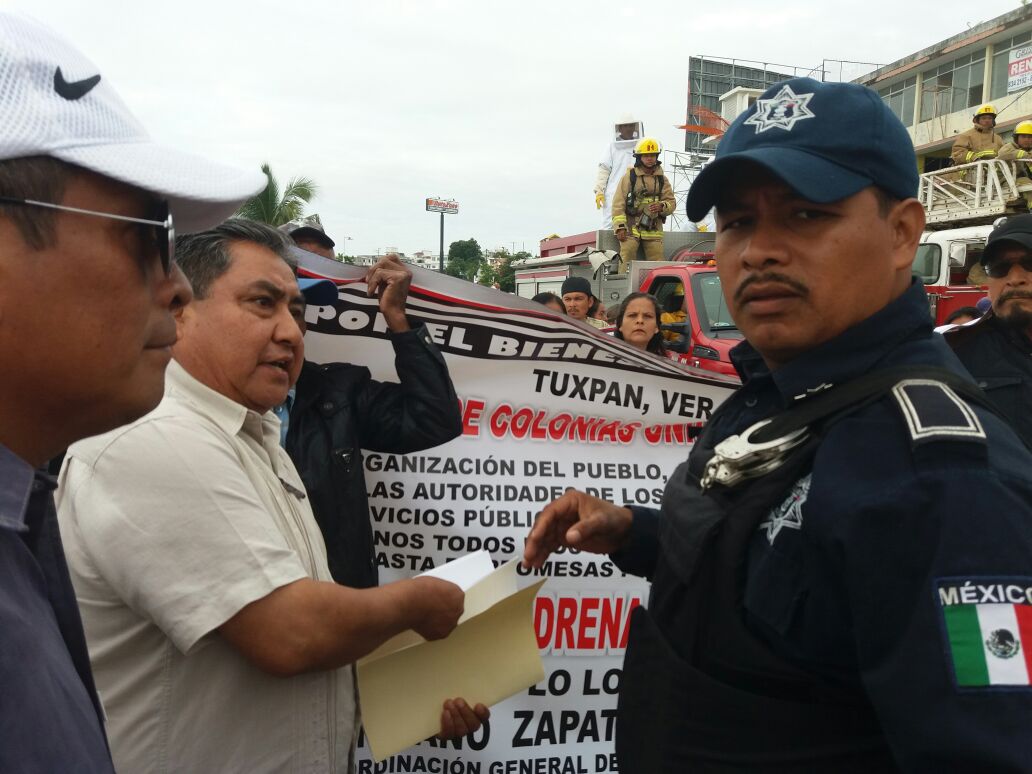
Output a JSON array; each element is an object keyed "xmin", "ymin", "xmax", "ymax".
[{"xmin": 938, "ymin": 578, "xmax": 1032, "ymax": 688}]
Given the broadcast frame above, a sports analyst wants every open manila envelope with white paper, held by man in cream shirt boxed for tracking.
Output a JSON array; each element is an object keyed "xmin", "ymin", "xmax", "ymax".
[{"xmin": 356, "ymin": 551, "xmax": 545, "ymax": 762}]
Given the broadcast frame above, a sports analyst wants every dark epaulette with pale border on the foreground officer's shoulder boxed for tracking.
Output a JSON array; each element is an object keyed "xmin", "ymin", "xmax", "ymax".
[{"xmin": 893, "ymin": 379, "xmax": 986, "ymax": 447}]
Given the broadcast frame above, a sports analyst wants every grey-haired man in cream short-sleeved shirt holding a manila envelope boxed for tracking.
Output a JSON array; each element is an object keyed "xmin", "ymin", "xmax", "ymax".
[{"xmin": 58, "ymin": 221, "xmax": 487, "ymax": 772}]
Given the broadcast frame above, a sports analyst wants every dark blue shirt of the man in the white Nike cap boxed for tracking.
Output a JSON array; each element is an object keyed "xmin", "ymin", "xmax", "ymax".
[{"xmin": 0, "ymin": 445, "xmax": 114, "ymax": 772}]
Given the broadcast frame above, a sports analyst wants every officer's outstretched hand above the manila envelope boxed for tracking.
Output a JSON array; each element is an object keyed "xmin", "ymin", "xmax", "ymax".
[{"xmin": 523, "ymin": 489, "xmax": 633, "ymax": 568}]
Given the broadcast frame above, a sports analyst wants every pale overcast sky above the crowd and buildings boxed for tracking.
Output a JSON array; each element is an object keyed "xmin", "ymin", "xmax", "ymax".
[{"xmin": 6, "ymin": 0, "xmax": 1020, "ymax": 255}]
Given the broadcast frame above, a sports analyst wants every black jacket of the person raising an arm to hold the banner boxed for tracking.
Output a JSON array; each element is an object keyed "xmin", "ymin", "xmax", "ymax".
[{"xmin": 287, "ymin": 326, "xmax": 462, "ymax": 588}]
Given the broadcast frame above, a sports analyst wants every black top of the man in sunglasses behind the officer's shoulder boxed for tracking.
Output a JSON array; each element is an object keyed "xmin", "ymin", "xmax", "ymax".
[{"xmin": 945, "ymin": 312, "xmax": 1032, "ymax": 449}]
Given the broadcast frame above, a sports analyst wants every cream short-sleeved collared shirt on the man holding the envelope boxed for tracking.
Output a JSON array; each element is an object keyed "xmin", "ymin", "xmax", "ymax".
[{"xmin": 58, "ymin": 361, "xmax": 357, "ymax": 773}]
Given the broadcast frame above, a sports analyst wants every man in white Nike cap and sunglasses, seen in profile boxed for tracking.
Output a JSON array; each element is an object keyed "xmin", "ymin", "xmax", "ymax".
[{"xmin": 0, "ymin": 13, "xmax": 264, "ymax": 772}]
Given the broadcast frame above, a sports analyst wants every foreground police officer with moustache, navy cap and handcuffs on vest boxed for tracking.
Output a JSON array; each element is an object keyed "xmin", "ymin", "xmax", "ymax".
[{"xmin": 524, "ymin": 78, "xmax": 1032, "ymax": 774}]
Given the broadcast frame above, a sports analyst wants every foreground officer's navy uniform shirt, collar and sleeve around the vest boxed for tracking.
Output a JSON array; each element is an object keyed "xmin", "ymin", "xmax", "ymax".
[{"xmin": 613, "ymin": 283, "xmax": 1032, "ymax": 772}]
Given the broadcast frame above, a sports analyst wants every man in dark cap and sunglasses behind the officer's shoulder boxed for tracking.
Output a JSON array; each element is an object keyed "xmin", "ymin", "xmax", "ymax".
[{"xmin": 945, "ymin": 215, "xmax": 1032, "ymax": 452}]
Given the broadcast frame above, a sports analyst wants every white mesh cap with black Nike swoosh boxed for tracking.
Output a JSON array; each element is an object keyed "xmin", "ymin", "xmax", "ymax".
[{"xmin": 0, "ymin": 12, "xmax": 267, "ymax": 233}]
